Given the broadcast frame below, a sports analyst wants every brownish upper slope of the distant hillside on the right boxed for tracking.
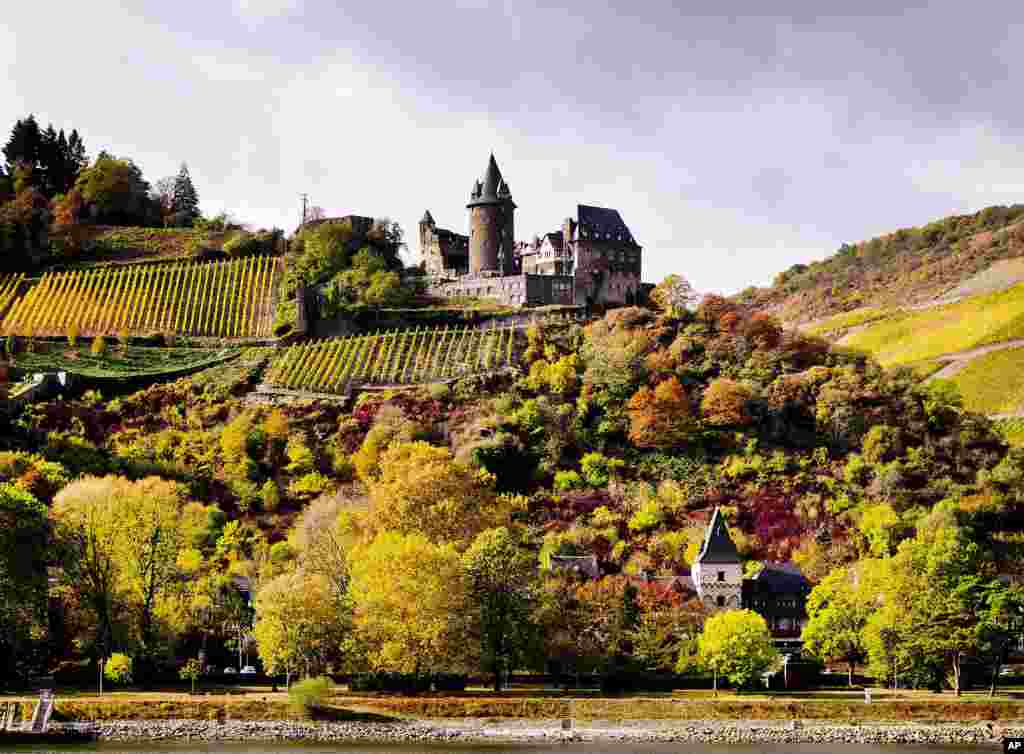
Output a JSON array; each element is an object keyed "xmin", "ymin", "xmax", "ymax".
[{"xmin": 737, "ymin": 205, "xmax": 1024, "ymax": 324}]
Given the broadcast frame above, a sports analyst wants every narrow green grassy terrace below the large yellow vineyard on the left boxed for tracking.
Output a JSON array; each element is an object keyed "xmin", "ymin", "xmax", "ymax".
[{"xmin": 13, "ymin": 346, "xmax": 233, "ymax": 377}]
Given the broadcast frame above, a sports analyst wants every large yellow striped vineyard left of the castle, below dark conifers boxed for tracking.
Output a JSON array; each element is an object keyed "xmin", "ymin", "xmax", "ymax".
[{"xmin": 0, "ymin": 256, "xmax": 281, "ymax": 338}]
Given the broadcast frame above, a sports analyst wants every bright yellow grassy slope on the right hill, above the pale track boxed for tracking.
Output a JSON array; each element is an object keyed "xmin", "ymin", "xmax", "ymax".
[{"xmin": 844, "ymin": 285, "xmax": 1024, "ymax": 367}]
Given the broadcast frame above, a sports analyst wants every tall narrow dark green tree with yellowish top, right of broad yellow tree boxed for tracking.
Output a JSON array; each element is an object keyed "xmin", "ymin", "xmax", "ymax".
[{"xmin": 462, "ymin": 527, "xmax": 537, "ymax": 692}]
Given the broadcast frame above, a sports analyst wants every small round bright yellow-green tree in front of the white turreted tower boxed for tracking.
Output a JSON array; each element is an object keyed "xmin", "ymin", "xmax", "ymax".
[{"xmin": 698, "ymin": 610, "xmax": 778, "ymax": 696}]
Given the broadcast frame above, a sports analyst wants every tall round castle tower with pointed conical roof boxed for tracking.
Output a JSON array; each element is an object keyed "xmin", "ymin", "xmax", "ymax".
[{"xmin": 466, "ymin": 154, "xmax": 515, "ymax": 275}]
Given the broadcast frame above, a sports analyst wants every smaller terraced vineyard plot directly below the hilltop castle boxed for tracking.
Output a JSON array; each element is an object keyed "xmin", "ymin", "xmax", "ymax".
[{"xmin": 265, "ymin": 328, "xmax": 515, "ymax": 392}]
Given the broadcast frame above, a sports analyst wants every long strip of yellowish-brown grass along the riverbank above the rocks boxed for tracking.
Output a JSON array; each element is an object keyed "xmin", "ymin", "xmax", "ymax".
[{"xmin": 9, "ymin": 689, "xmax": 1024, "ymax": 722}]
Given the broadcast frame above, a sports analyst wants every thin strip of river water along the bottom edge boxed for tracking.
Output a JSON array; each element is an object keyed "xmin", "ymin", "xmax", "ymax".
[{"xmin": 0, "ymin": 742, "xmax": 1001, "ymax": 754}]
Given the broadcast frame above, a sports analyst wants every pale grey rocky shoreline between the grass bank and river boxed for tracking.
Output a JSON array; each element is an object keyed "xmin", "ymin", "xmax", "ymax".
[{"xmin": 51, "ymin": 719, "xmax": 1024, "ymax": 747}]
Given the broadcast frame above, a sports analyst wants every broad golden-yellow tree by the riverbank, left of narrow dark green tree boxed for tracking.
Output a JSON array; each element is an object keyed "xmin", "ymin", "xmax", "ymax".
[{"xmin": 349, "ymin": 532, "xmax": 468, "ymax": 673}]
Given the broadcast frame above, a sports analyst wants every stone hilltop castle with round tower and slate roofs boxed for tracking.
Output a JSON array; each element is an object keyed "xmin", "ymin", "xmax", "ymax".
[{"xmin": 419, "ymin": 155, "xmax": 643, "ymax": 306}]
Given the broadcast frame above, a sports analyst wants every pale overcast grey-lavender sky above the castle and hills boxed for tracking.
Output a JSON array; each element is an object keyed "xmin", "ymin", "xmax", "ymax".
[{"xmin": 0, "ymin": 0, "xmax": 1024, "ymax": 292}]
